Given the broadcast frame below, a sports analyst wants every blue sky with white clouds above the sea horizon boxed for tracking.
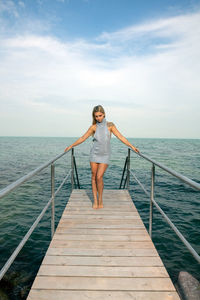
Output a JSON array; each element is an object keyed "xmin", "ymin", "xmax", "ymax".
[{"xmin": 0, "ymin": 0, "xmax": 200, "ymax": 139}]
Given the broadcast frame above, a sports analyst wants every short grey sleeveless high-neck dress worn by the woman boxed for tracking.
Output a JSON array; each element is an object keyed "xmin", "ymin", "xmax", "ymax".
[{"xmin": 90, "ymin": 118, "xmax": 111, "ymax": 164}]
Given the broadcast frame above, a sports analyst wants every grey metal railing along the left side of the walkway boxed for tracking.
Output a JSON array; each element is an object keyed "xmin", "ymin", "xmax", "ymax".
[{"xmin": 0, "ymin": 148, "xmax": 80, "ymax": 280}]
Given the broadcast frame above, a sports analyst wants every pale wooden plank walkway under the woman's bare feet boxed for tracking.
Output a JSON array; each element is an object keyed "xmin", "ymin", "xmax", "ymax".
[{"xmin": 27, "ymin": 190, "xmax": 180, "ymax": 300}]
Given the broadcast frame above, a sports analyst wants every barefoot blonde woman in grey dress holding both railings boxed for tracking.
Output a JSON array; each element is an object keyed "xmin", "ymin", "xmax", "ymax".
[{"xmin": 65, "ymin": 105, "xmax": 139, "ymax": 209}]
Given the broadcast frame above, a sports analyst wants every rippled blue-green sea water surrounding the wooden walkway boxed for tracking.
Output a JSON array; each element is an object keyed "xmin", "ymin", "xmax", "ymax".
[{"xmin": 0, "ymin": 137, "xmax": 200, "ymax": 300}]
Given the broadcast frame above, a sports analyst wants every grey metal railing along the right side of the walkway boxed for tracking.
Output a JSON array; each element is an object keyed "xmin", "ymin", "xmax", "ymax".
[{"xmin": 119, "ymin": 148, "xmax": 200, "ymax": 263}]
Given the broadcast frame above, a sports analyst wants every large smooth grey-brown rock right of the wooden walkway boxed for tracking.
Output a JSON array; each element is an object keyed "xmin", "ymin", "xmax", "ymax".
[{"xmin": 178, "ymin": 271, "xmax": 200, "ymax": 300}]
